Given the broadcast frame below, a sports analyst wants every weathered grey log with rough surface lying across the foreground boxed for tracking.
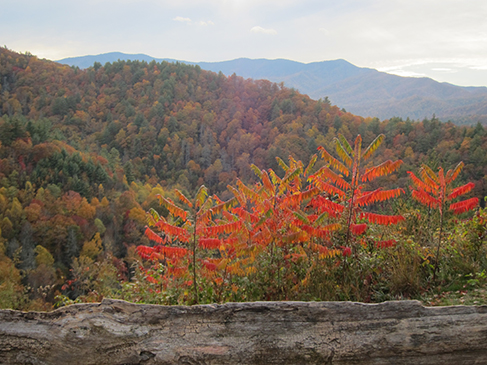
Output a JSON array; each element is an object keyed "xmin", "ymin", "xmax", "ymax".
[{"xmin": 0, "ymin": 300, "xmax": 487, "ymax": 365}]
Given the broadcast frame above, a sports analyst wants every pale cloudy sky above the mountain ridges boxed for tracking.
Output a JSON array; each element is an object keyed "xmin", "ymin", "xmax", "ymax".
[{"xmin": 0, "ymin": 0, "xmax": 487, "ymax": 86}]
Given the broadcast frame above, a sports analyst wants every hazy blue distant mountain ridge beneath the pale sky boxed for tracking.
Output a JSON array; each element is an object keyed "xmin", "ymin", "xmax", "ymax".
[{"xmin": 57, "ymin": 52, "xmax": 487, "ymax": 124}]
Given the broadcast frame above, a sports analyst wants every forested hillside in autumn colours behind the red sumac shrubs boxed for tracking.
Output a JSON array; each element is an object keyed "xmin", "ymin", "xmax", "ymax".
[{"xmin": 0, "ymin": 48, "xmax": 487, "ymax": 308}]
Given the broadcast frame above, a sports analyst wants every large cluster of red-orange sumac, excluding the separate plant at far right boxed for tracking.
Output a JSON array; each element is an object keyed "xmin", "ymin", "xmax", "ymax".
[{"xmin": 133, "ymin": 136, "xmax": 412, "ymax": 302}]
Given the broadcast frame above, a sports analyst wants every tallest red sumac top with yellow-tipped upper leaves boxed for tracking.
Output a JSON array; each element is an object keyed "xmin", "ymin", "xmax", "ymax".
[{"xmin": 308, "ymin": 134, "xmax": 404, "ymax": 250}]
